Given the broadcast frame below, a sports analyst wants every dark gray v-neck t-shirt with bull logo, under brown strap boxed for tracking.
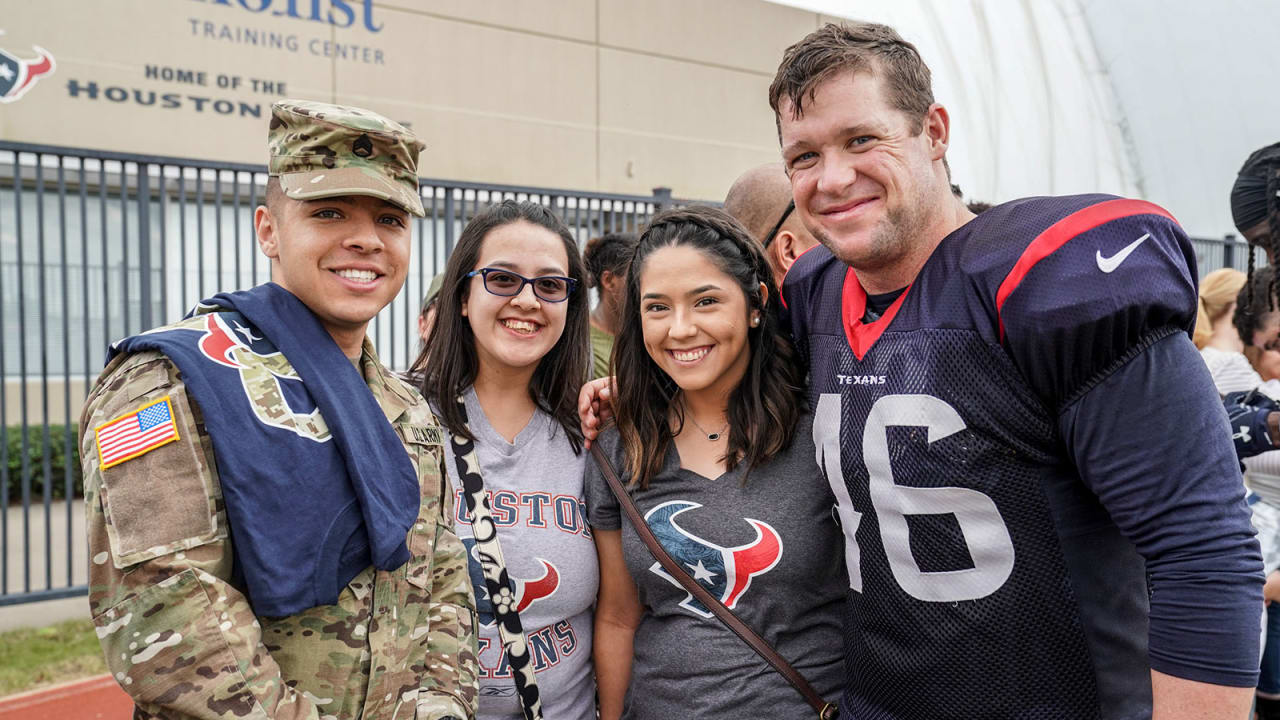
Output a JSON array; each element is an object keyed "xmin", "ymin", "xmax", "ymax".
[{"xmin": 586, "ymin": 415, "xmax": 849, "ymax": 720}]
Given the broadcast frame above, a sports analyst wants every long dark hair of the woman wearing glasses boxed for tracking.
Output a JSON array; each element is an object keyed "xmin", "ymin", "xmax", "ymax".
[{"xmin": 410, "ymin": 200, "xmax": 590, "ymax": 452}]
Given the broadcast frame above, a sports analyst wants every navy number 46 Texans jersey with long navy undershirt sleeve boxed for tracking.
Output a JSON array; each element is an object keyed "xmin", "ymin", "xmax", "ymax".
[{"xmin": 783, "ymin": 195, "xmax": 1261, "ymax": 720}]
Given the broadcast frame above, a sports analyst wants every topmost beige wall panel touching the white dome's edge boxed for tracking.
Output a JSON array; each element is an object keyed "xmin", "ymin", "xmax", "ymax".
[{"xmin": 599, "ymin": 0, "xmax": 814, "ymax": 78}]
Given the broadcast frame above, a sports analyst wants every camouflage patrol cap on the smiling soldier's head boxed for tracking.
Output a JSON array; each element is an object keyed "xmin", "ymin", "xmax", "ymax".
[{"xmin": 266, "ymin": 100, "xmax": 426, "ymax": 218}]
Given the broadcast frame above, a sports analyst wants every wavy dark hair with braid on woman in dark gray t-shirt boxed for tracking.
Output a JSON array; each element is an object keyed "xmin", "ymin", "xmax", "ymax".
[{"xmin": 609, "ymin": 205, "xmax": 804, "ymax": 488}]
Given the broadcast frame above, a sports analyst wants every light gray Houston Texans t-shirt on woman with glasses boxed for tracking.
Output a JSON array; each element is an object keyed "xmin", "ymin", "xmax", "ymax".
[{"xmin": 445, "ymin": 389, "xmax": 599, "ymax": 720}]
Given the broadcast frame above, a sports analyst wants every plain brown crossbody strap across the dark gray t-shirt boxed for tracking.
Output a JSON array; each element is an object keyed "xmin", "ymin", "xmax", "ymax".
[{"xmin": 591, "ymin": 443, "xmax": 836, "ymax": 720}]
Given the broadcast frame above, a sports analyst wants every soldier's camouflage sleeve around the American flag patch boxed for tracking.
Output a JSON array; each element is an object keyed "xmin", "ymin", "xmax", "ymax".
[{"xmin": 81, "ymin": 354, "xmax": 319, "ymax": 720}]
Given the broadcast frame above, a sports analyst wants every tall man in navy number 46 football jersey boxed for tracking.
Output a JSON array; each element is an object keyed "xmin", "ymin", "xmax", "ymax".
[{"xmin": 769, "ymin": 23, "xmax": 1262, "ymax": 720}]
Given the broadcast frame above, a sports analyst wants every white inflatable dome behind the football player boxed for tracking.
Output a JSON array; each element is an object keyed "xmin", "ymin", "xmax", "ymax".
[{"xmin": 776, "ymin": 0, "xmax": 1280, "ymax": 237}]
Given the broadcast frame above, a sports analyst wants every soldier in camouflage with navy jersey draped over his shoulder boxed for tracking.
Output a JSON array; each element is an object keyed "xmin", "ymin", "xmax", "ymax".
[{"xmin": 81, "ymin": 101, "xmax": 477, "ymax": 720}]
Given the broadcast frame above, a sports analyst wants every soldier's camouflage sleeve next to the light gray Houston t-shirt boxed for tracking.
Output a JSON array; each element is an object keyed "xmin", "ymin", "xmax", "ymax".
[{"xmin": 417, "ymin": 453, "xmax": 480, "ymax": 720}]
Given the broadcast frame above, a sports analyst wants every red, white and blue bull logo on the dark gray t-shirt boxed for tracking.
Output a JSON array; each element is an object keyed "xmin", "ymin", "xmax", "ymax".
[{"xmin": 645, "ymin": 500, "xmax": 782, "ymax": 618}]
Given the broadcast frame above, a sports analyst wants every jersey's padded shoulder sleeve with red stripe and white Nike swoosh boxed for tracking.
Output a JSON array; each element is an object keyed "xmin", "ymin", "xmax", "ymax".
[{"xmin": 986, "ymin": 196, "xmax": 1197, "ymax": 407}]
